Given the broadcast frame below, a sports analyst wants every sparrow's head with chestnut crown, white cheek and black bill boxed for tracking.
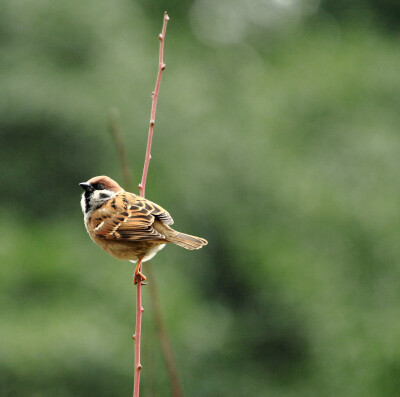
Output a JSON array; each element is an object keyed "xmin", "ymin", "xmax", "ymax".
[{"xmin": 79, "ymin": 175, "xmax": 124, "ymax": 214}]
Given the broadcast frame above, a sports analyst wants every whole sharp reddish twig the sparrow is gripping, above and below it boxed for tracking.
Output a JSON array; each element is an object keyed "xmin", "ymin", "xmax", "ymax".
[{"xmin": 133, "ymin": 12, "xmax": 169, "ymax": 397}]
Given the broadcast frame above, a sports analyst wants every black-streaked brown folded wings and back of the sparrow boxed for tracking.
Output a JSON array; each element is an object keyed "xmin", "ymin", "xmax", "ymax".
[{"xmin": 91, "ymin": 192, "xmax": 173, "ymax": 241}]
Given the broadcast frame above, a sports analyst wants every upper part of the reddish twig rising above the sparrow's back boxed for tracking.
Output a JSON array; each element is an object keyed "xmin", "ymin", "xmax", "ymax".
[{"xmin": 138, "ymin": 11, "xmax": 169, "ymax": 197}]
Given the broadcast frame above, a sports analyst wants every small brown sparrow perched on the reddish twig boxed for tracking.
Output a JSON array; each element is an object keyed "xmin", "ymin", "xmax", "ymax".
[{"xmin": 79, "ymin": 175, "xmax": 207, "ymax": 284}]
